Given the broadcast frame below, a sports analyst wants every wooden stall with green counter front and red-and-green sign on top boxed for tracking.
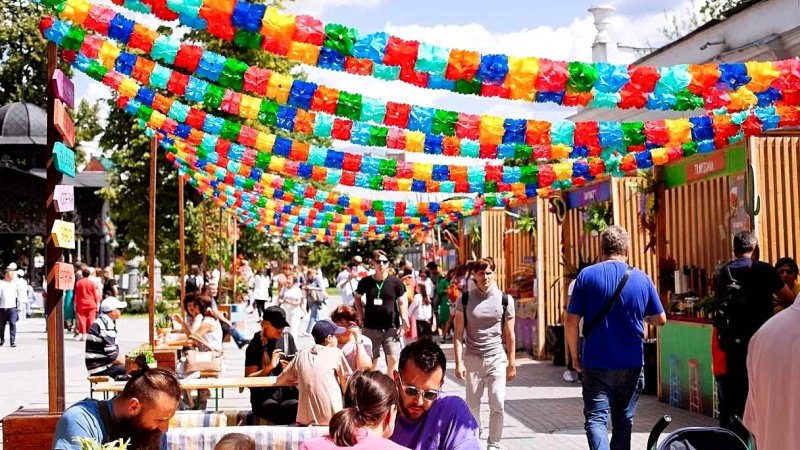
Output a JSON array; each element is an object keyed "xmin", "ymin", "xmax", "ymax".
[{"xmin": 658, "ymin": 144, "xmax": 750, "ymax": 415}]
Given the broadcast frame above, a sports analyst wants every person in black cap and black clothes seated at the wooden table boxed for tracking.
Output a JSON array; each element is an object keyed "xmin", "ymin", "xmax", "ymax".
[{"xmin": 244, "ymin": 306, "xmax": 299, "ymax": 425}]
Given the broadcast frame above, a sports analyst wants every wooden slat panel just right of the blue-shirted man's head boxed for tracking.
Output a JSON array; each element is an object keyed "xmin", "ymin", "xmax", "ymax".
[{"xmin": 611, "ymin": 178, "xmax": 658, "ymax": 286}]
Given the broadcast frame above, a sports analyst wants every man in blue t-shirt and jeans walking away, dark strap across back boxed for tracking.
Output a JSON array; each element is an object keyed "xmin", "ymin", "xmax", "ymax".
[{"xmin": 566, "ymin": 226, "xmax": 667, "ymax": 450}]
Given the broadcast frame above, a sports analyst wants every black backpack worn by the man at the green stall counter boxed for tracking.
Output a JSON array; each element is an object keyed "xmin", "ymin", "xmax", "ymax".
[{"xmin": 713, "ymin": 264, "xmax": 749, "ymax": 352}]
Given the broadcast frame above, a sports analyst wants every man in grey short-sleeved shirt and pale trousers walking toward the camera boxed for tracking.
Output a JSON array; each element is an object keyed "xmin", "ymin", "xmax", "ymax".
[{"xmin": 453, "ymin": 258, "xmax": 517, "ymax": 449}]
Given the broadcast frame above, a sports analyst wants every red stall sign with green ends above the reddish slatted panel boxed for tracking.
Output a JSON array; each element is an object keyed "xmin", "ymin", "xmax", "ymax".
[{"xmin": 664, "ymin": 145, "xmax": 747, "ymax": 189}]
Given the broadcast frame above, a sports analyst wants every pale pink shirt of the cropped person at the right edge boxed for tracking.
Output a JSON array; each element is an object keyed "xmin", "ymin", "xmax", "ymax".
[{"xmin": 744, "ymin": 297, "xmax": 800, "ymax": 450}]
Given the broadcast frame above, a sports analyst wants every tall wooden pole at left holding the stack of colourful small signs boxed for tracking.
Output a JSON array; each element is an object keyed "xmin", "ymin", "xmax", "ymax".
[{"xmin": 45, "ymin": 42, "xmax": 65, "ymax": 413}]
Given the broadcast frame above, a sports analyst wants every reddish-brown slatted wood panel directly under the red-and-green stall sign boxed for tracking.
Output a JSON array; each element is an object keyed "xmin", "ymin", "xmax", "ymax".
[{"xmin": 665, "ymin": 177, "xmax": 731, "ymax": 276}]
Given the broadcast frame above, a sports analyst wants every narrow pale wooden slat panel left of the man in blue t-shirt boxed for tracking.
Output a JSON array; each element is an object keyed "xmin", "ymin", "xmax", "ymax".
[{"xmin": 536, "ymin": 200, "xmax": 567, "ymax": 358}]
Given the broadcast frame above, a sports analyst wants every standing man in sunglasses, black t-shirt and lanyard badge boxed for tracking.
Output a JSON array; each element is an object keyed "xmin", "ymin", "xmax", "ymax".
[{"xmin": 355, "ymin": 250, "xmax": 408, "ymax": 374}]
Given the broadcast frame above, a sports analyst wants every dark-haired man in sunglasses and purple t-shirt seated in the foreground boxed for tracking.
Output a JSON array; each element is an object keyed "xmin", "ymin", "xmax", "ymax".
[{"xmin": 391, "ymin": 338, "xmax": 480, "ymax": 450}]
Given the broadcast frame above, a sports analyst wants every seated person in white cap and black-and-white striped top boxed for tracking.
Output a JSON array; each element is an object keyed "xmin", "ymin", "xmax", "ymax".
[{"xmin": 86, "ymin": 297, "xmax": 128, "ymax": 378}]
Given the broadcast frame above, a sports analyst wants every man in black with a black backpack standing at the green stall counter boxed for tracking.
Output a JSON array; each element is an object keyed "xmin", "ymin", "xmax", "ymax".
[{"xmin": 712, "ymin": 231, "xmax": 794, "ymax": 433}]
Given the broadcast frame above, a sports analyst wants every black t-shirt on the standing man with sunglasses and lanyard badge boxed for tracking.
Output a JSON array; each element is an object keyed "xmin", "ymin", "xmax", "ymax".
[{"xmin": 356, "ymin": 275, "xmax": 406, "ymax": 330}]
